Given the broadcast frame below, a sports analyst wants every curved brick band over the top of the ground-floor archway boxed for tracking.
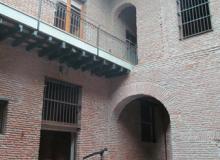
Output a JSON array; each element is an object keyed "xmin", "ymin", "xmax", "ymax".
[{"xmin": 111, "ymin": 82, "xmax": 175, "ymax": 121}]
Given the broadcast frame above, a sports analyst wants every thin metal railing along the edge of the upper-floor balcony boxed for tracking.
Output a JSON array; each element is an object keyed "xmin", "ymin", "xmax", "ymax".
[{"xmin": 0, "ymin": 0, "xmax": 137, "ymax": 65}]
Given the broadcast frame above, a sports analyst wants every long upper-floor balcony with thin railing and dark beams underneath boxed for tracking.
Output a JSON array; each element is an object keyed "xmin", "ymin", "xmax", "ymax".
[{"xmin": 0, "ymin": 0, "xmax": 137, "ymax": 78}]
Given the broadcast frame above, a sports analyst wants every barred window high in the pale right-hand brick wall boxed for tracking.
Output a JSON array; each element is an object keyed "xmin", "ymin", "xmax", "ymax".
[{"xmin": 177, "ymin": 0, "xmax": 212, "ymax": 39}]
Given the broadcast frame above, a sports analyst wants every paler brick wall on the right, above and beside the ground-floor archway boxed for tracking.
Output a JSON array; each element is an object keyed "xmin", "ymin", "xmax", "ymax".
[{"xmin": 111, "ymin": 0, "xmax": 220, "ymax": 160}]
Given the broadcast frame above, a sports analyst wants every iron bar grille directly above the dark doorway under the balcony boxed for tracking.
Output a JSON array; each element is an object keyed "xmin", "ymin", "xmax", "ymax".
[{"xmin": 42, "ymin": 78, "xmax": 81, "ymax": 124}]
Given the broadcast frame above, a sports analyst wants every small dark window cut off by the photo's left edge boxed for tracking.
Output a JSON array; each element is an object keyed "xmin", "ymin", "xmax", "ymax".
[{"xmin": 0, "ymin": 100, "xmax": 8, "ymax": 134}]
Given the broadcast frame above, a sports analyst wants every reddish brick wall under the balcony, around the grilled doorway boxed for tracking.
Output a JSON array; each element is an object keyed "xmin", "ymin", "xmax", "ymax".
[{"xmin": 0, "ymin": 41, "xmax": 108, "ymax": 160}]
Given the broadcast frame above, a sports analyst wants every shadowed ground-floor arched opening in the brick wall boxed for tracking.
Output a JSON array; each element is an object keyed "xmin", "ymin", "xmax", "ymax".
[{"xmin": 112, "ymin": 95, "xmax": 171, "ymax": 160}]
